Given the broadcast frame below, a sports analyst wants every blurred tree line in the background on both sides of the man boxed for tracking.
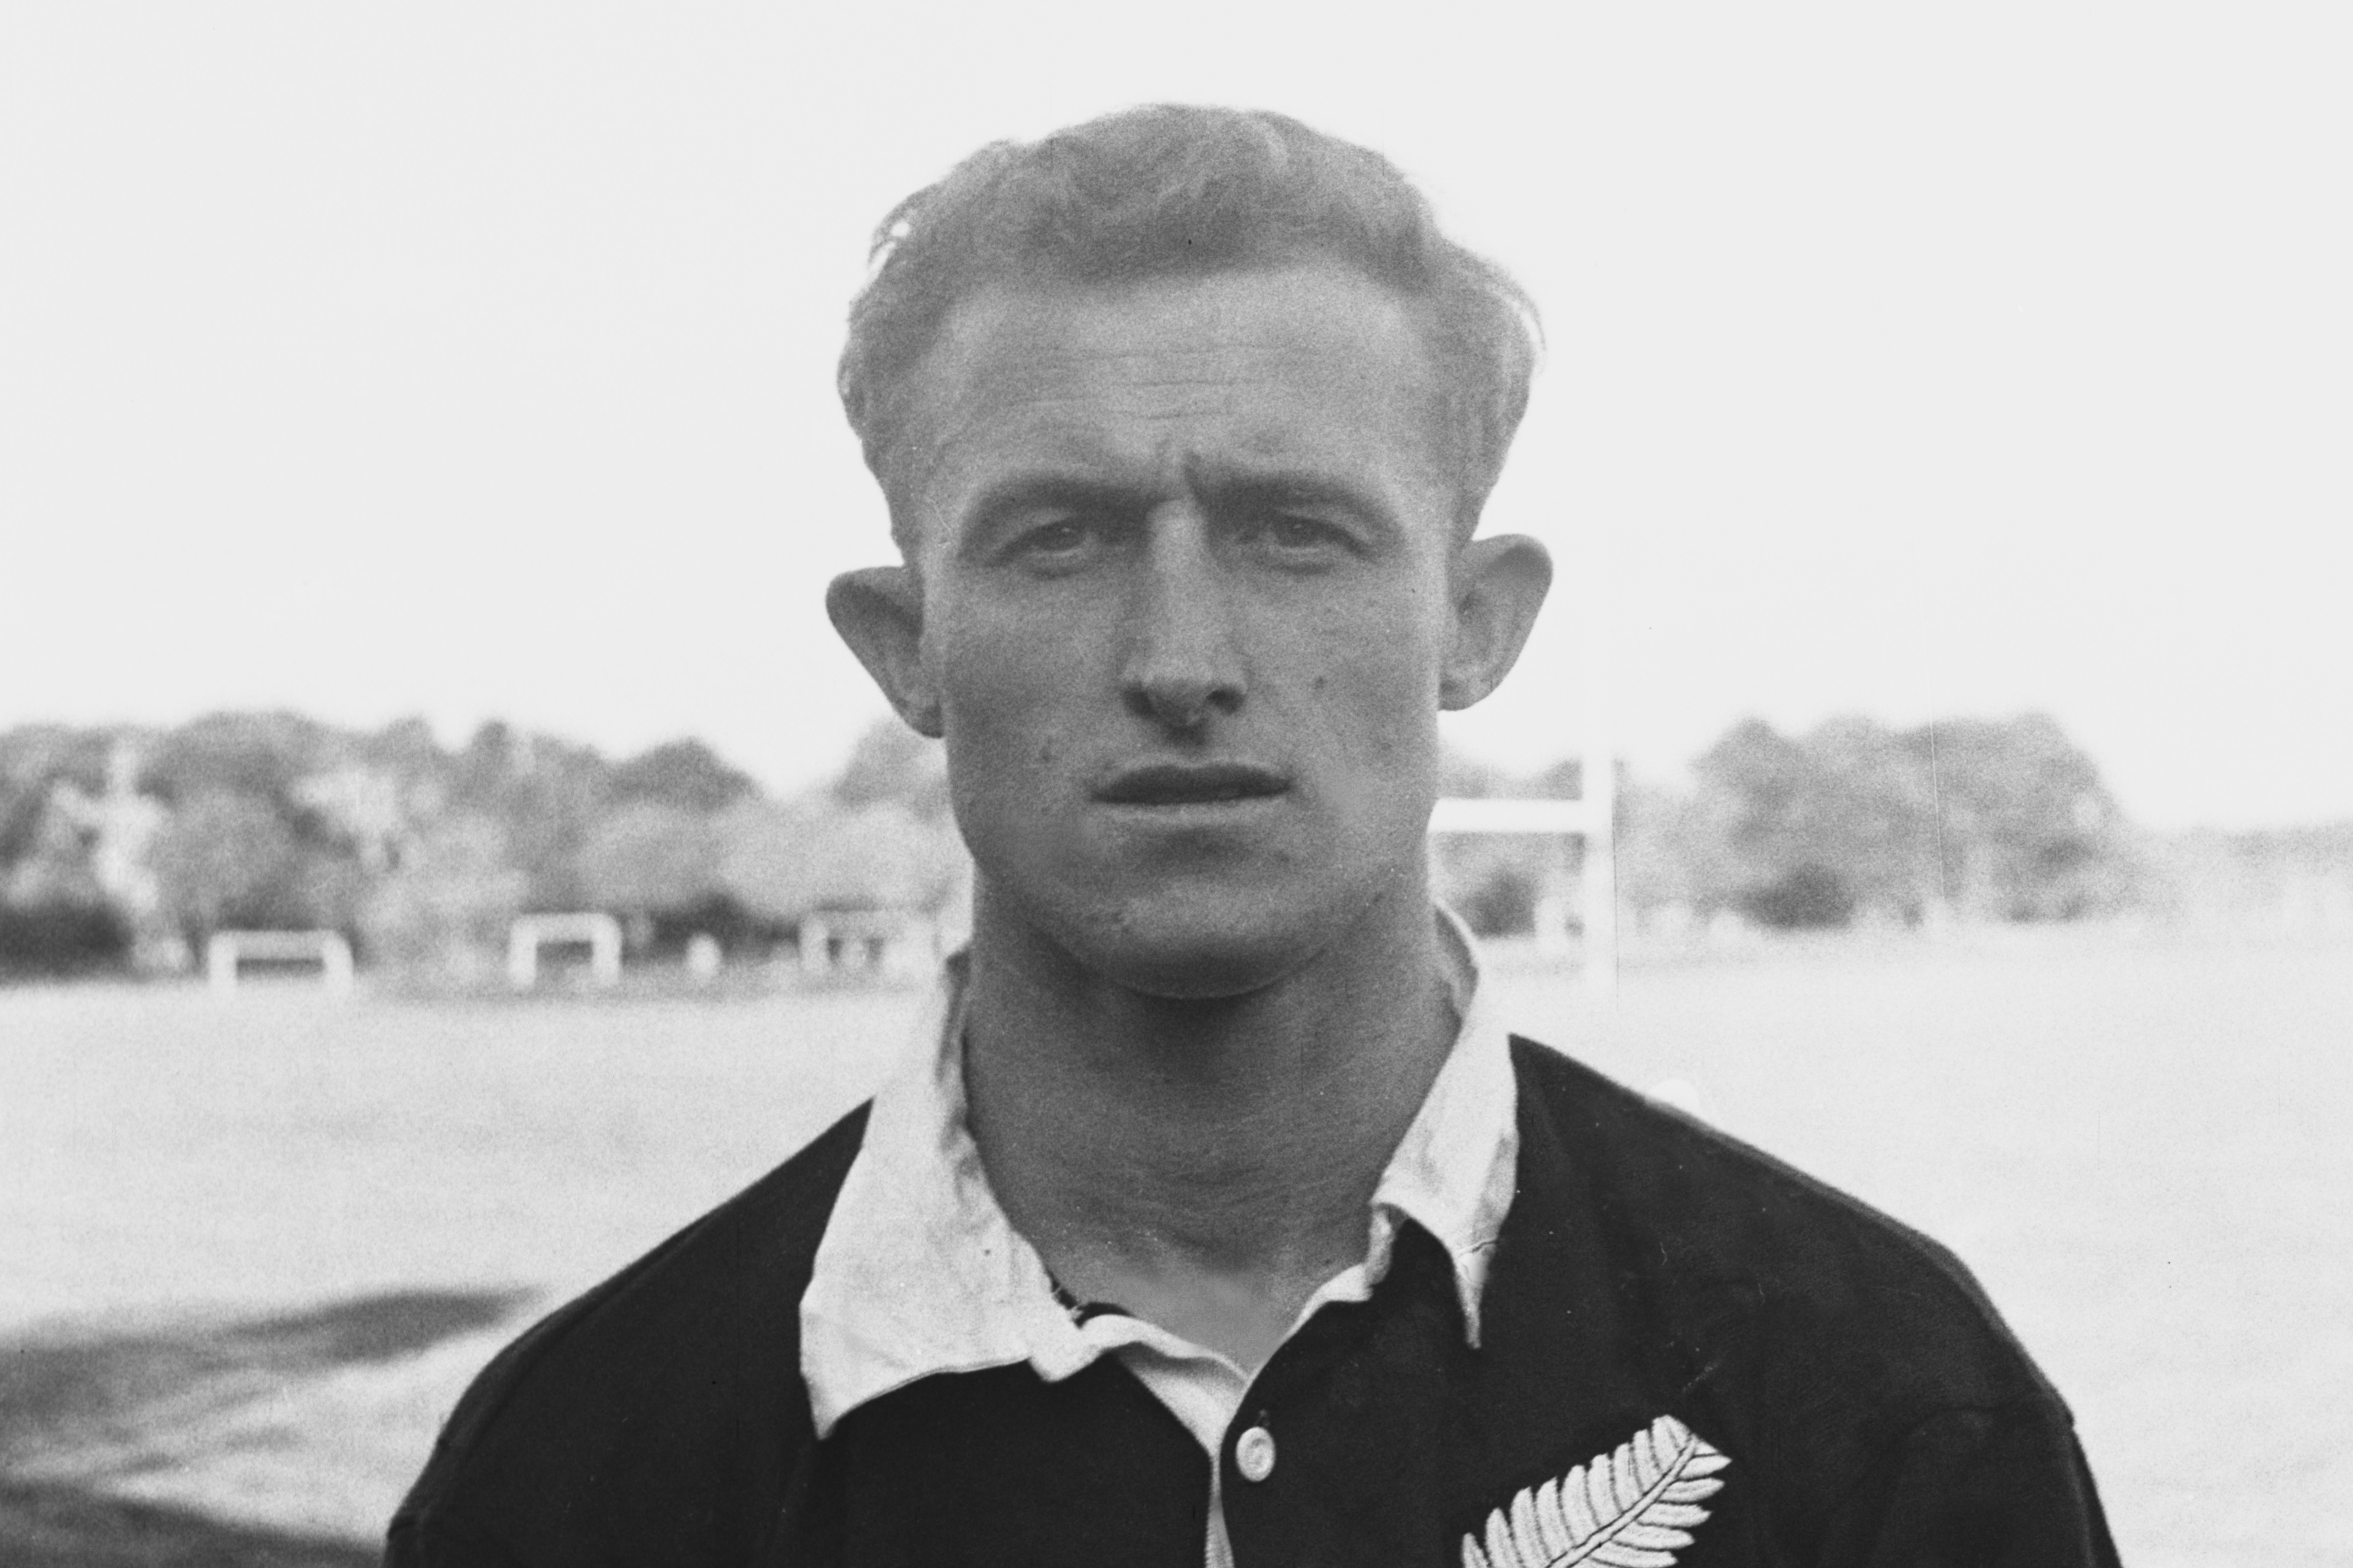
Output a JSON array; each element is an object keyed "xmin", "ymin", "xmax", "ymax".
[{"xmin": 0, "ymin": 713, "xmax": 2268, "ymax": 977}]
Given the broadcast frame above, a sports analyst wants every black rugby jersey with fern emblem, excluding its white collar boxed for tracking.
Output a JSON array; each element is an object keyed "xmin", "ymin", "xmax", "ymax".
[{"xmin": 388, "ymin": 1041, "xmax": 2115, "ymax": 1568}]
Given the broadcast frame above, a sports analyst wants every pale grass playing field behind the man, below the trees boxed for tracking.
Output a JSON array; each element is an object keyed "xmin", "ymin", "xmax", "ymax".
[{"xmin": 0, "ymin": 934, "xmax": 2353, "ymax": 1568}]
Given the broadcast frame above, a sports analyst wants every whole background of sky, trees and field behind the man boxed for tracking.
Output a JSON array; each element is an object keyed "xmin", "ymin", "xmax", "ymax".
[{"xmin": 0, "ymin": 0, "xmax": 2353, "ymax": 1563}]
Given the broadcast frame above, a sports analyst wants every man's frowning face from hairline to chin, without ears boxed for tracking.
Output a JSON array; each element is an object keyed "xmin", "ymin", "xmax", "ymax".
[{"xmin": 901, "ymin": 266, "xmax": 1454, "ymax": 996}]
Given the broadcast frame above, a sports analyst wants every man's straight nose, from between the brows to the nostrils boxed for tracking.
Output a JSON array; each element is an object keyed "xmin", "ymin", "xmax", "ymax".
[{"xmin": 1120, "ymin": 504, "xmax": 1245, "ymax": 732}]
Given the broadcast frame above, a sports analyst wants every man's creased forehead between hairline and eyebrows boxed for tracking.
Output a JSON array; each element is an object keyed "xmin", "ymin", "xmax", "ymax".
[{"xmin": 904, "ymin": 266, "xmax": 1447, "ymax": 537}]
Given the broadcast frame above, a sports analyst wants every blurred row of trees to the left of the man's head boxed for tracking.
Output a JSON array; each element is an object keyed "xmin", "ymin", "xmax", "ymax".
[{"xmin": 0, "ymin": 713, "xmax": 962, "ymax": 979}]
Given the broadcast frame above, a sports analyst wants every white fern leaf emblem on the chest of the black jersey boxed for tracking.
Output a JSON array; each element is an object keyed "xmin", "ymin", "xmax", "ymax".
[{"xmin": 1463, "ymin": 1415, "xmax": 1732, "ymax": 1568}]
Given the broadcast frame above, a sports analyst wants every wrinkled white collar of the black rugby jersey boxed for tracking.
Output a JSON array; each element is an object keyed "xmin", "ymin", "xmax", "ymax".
[{"xmin": 800, "ymin": 911, "xmax": 1520, "ymax": 1436}]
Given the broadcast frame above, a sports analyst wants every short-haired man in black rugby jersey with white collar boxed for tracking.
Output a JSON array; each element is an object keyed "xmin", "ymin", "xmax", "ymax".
[{"xmin": 391, "ymin": 108, "xmax": 2113, "ymax": 1568}]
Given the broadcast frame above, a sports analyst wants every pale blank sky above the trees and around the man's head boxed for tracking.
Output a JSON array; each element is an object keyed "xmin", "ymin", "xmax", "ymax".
[{"xmin": 0, "ymin": 0, "xmax": 2353, "ymax": 826}]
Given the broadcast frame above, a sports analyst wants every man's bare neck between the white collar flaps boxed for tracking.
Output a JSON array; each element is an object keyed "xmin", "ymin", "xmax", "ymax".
[{"xmin": 965, "ymin": 883, "xmax": 1454, "ymax": 1363}]
